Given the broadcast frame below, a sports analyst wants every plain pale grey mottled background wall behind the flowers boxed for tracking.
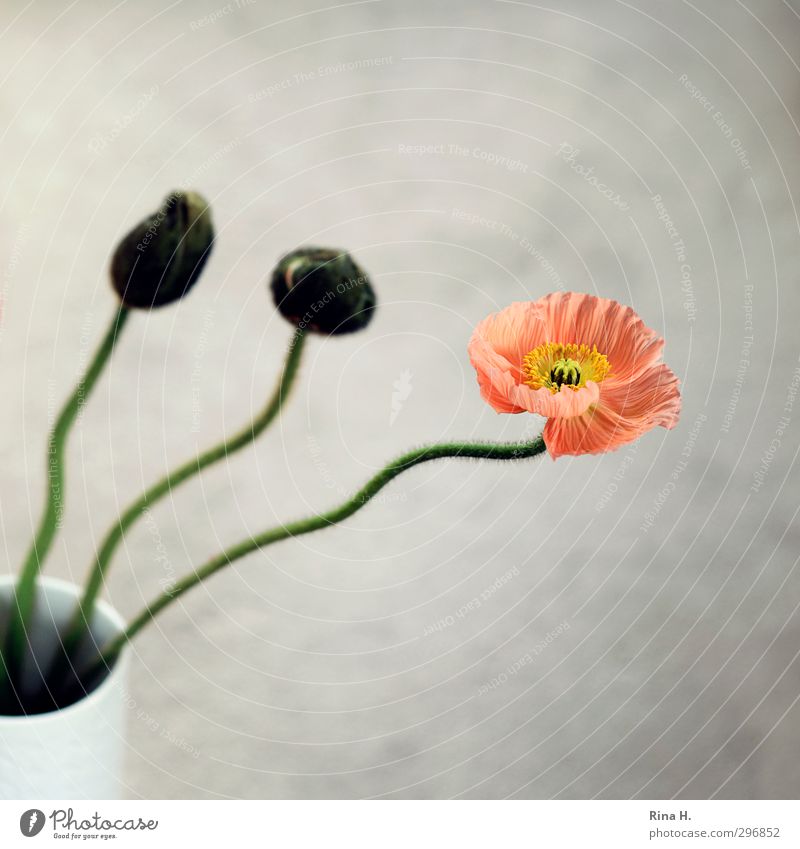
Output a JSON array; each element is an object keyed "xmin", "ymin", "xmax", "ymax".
[{"xmin": 0, "ymin": 0, "xmax": 800, "ymax": 798}]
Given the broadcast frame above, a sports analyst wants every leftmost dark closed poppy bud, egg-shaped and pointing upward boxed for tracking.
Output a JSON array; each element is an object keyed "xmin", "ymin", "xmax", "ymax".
[{"xmin": 111, "ymin": 191, "xmax": 214, "ymax": 309}]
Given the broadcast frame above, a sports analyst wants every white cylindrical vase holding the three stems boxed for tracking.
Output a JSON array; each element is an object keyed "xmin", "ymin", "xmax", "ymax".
[{"xmin": 0, "ymin": 576, "xmax": 128, "ymax": 800}]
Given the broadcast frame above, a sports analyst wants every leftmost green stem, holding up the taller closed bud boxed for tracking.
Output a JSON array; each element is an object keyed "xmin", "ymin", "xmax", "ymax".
[{"xmin": 0, "ymin": 306, "xmax": 130, "ymax": 684}]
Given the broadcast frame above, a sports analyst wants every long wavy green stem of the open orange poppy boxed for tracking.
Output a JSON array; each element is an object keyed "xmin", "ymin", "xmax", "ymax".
[{"xmin": 81, "ymin": 436, "xmax": 545, "ymax": 680}]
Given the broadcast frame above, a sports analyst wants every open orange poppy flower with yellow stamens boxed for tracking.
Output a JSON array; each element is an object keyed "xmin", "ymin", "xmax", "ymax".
[{"xmin": 468, "ymin": 292, "xmax": 681, "ymax": 459}]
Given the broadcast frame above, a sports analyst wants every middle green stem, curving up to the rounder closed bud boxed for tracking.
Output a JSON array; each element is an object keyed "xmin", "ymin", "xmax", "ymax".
[{"xmin": 61, "ymin": 328, "xmax": 306, "ymax": 662}]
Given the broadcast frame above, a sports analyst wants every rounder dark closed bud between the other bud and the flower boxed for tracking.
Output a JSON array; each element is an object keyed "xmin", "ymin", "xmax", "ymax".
[{"xmin": 271, "ymin": 247, "xmax": 376, "ymax": 335}]
